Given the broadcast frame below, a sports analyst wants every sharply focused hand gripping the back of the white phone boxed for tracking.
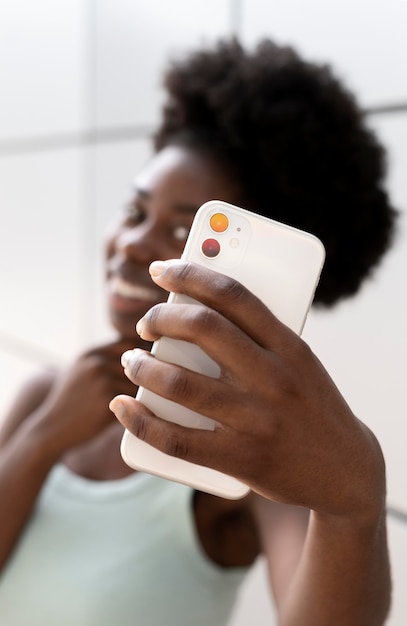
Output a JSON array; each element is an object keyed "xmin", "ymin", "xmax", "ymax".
[{"xmin": 110, "ymin": 261, "xmax": 385, "ymax": 517}]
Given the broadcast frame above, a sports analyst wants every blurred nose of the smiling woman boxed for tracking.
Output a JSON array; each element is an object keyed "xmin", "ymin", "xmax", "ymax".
[{"xmin": 115, "ymin": 222, "xmax": 163, "ymax": 264}]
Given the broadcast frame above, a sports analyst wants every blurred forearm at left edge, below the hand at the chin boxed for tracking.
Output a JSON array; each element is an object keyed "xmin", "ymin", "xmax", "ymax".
[{"xmin": 0, "ymin": 415, "xmax": 58, "ymax": 570}]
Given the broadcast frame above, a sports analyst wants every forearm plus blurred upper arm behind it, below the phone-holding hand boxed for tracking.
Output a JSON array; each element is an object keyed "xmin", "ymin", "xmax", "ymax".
[{"xmin": 253, "ymin": 497, "xmax": 390, "ymax": 626}]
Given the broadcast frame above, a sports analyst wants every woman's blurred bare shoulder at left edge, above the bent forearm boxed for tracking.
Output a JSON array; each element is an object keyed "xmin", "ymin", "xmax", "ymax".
[{"xmin": 0, "ymin": 367, "xmax": 59, "ymax": 444}]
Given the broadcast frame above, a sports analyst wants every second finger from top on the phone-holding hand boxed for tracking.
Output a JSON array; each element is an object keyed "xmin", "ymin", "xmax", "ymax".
[{"xmin": 137, "ymin": 303, "xmax": 264, "ymax": 380}]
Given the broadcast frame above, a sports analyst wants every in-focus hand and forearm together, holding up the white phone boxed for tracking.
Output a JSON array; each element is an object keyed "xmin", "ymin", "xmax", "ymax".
[{"xmin": 111, "ymin": 262, "xmax": 390, "ymax": 626}]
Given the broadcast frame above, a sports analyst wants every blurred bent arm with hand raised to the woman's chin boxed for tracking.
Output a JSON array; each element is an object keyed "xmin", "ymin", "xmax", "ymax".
[{"xmin": 0, "ymin": 342, "xmax": 134, "ymax": 568}]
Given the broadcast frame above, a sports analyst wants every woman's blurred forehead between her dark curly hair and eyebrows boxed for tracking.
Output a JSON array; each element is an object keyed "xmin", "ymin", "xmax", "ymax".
[{"xmin": 133, "ymin": 146, "xmax": 240, "ymax": 207}]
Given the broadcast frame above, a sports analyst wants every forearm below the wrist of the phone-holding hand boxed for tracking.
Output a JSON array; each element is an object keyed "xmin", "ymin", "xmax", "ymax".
[{"xmin": 280, "ymin": 510, "xmax": 391, "ymax": 626}]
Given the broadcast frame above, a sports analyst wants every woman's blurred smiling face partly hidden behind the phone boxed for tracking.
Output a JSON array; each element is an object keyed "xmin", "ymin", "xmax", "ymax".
[{"xmin": 106, "ymin": 146, "xmax": 244, "ymax": 338}]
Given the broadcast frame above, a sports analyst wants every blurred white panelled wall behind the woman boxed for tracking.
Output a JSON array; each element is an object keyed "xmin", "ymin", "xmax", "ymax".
[{"xmin": 0, "ymin": 0, "xmax": 407, "ymax": 626}]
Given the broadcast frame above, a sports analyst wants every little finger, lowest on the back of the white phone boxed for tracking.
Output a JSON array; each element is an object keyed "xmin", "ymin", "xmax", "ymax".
[{"xmin": 109, "ymin": 395, "xmax": 245, "ymax": 476}]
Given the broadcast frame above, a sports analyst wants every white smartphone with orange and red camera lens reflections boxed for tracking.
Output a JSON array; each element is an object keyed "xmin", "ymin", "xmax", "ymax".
[{"xmin": 121, "ymin": 200, "xmax": 325, "ymax": 499}]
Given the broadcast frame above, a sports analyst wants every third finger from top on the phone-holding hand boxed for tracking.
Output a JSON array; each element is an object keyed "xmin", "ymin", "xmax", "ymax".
[{"xmin": 119, "ymin": 348, "xmax": 241, "ymax": 424}]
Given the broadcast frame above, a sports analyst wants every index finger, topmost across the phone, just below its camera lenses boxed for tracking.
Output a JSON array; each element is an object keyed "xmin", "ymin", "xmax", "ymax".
[{"xmin": 150, "ymin": 260, "xmax": 293, "ymax": 348}]
